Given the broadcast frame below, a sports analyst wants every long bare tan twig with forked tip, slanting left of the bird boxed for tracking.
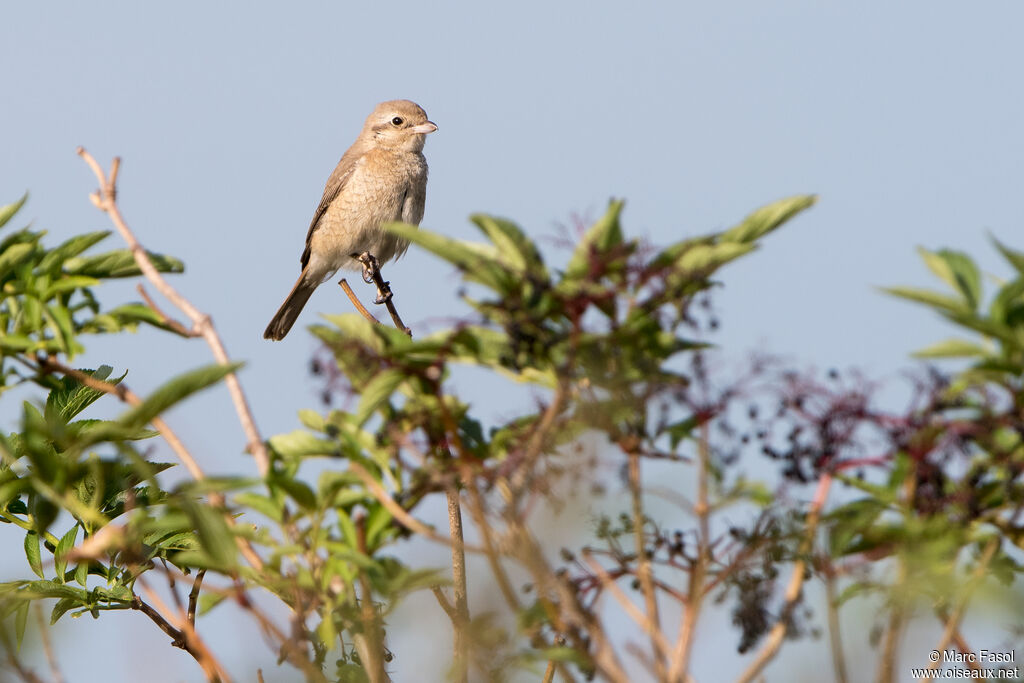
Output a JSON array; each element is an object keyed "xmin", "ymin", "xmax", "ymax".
[{"xmin": 78, "ymin": 147, "xmax": 270, "ymax": 476}]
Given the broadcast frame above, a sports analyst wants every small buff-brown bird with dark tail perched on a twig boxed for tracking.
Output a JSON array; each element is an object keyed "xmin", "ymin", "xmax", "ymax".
[{"xmin": 263, "ymin": 99, "xmax": 437, "ymax": 341}]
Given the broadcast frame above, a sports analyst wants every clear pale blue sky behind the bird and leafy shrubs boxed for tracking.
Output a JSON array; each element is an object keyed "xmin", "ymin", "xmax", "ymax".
[{"xmin": 0, "ymin": 0, "xmax": 1024, "ymax": 683}]
